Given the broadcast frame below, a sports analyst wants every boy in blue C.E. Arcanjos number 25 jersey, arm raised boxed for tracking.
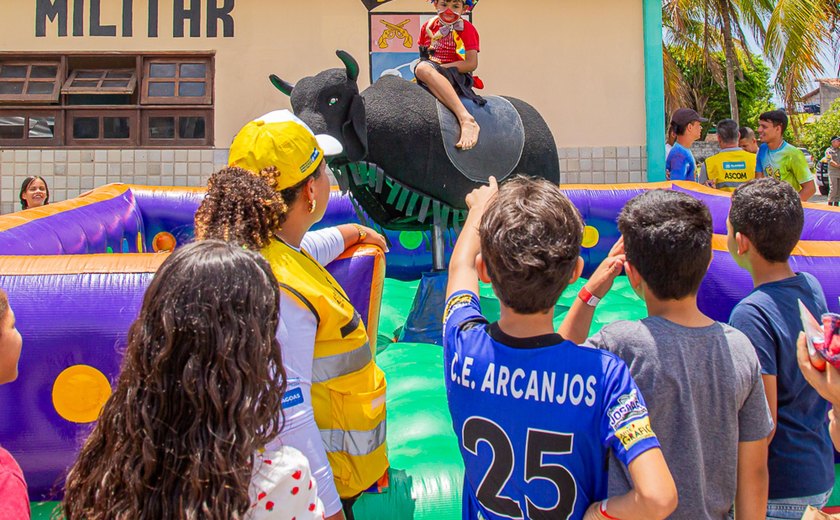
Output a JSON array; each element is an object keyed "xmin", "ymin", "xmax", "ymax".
[{"xmin": 444, "ymin": 177, "xmax": 677, "ymax": 520}]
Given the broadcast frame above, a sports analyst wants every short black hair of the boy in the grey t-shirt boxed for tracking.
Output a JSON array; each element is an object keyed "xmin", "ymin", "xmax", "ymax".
[{"xmin": 618, "ymin": 190, "xmax": 712, "ymax": 300}]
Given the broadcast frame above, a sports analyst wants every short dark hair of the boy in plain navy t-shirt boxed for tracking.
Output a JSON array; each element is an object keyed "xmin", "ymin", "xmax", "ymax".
[{"xmin": 729, "ymin": 178, "xmax": 805, "ymax": 262}]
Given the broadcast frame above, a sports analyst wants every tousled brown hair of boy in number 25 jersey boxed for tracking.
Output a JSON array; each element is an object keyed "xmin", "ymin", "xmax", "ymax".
[{"xmin": 479, "ymin": 175, "xmax": 583, "ymax": 314}]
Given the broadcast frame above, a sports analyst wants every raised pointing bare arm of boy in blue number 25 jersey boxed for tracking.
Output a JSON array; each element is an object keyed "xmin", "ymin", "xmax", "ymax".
[{"xmin": 446, "ymin": 177, "xmax": 499, "ymax": 300}]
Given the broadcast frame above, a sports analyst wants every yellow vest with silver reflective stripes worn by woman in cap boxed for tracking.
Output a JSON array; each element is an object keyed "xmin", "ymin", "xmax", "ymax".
[{"xmin": 261, "ymin": 240, "xmax": 388, "ymax": 498}]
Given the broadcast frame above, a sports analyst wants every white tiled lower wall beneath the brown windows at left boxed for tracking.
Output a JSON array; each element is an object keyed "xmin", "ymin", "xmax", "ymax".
[{"xmin": 0, "ymin": 149, "xmax": 228, "ymax": 214}]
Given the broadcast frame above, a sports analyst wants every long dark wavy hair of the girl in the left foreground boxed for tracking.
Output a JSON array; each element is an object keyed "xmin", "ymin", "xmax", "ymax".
[{"xmin": 63, "ymin": 240, "xmax": 286, "ymax": 520}]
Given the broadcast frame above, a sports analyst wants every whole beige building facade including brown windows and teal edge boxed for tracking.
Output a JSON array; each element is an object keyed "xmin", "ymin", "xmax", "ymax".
[{"xmin": 0, "ymin": 0, "xmax": 664, "ymax": 213}]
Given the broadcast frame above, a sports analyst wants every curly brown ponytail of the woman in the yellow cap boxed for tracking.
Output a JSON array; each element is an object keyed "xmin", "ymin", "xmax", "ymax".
[{"xmin": 195, "ymin": 166, "xmax": 288, "ymax": 250}]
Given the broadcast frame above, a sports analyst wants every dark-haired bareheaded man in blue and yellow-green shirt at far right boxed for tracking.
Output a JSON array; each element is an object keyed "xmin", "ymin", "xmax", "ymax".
[{"xmin": 755, "ymin": 110, "xmax": 817, "ymax": 202}]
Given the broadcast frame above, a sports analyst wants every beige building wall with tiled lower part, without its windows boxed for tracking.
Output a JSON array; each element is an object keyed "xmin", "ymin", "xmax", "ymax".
[{"xmin": 0, "ymin": 0, "xmax": 645, "ymax": 212}]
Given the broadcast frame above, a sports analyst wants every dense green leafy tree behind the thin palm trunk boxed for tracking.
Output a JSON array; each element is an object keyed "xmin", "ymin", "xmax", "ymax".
[{"xmin": 669, "ymin": 47, "xmax": 776, "ymax": 133}]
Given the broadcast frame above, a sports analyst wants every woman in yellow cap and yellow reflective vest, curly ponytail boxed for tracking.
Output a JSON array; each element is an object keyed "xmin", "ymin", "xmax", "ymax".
[{"xmin": 196, "ymin": 110, "xmax": 388, "ymax": 519}]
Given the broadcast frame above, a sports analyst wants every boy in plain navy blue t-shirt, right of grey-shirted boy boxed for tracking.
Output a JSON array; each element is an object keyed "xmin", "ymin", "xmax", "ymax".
[{"xmin": 727, "ymin": 179, "xmax": 834, "ymax": 518}]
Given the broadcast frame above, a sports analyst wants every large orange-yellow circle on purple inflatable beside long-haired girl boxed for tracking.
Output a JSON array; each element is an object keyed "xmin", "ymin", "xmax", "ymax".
[{"xmin": 52, "ymin": 365, "xmax": 111, "ymax": 424}]
